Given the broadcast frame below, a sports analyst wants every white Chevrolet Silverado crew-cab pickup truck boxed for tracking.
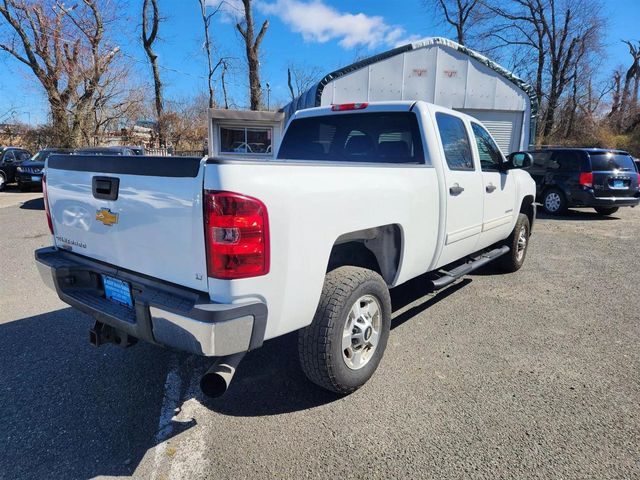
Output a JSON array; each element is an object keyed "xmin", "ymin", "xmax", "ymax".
[{"xmin": 35, "ymin": 101, "xmax": 536, "ymax": 395}]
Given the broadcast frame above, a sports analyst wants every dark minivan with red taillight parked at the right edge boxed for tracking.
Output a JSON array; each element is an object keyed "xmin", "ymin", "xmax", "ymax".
[{"xmin": 527, "ymin": 148, "xmax": 640, "ymax": 215}]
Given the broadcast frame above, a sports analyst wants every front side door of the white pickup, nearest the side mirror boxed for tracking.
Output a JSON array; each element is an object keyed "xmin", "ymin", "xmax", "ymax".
[{"xmin": 471, "ymin": 122, "xmax": 516, "ymax": 248}]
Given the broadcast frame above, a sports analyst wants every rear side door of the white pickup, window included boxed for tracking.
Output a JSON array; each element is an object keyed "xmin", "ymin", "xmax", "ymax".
[{"xmin": 435, "ymin": 112, "xmax": 483, "ymax": 266}]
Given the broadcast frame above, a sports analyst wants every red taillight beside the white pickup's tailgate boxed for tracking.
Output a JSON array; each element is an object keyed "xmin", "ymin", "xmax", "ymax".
[{"xmin": 204, "ymin": 191, "xmax": 269, "ymax": 279}]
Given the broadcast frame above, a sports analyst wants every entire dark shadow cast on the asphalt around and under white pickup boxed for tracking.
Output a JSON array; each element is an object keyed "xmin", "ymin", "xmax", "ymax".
[{"xmin": 0, "ymin": 277, "xmax": 476, "ymax": 479}]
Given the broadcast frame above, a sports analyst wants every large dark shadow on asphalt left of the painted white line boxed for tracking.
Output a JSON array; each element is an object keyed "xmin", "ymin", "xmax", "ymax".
[{"xmin": 0, "ymin": 308, "xmax": 195, "ymax": 479}]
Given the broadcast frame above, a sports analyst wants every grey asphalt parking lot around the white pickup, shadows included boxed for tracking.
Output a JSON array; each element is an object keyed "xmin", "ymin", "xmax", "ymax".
[{"xmin": 0, "ymin": 191, "xmax": 640, "ymax": 479}]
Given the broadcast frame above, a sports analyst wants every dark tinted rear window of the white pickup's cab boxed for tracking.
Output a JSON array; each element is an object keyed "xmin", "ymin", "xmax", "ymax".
[{"xmin": 278, "ymin": 112, "xmax": 424, "ymax": 164}]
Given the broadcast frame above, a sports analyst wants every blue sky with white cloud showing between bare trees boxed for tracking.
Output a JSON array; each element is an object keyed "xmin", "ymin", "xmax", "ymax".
[{"xmin": 0, "ymin": 0, "xmax": 640, "ymax": 122}]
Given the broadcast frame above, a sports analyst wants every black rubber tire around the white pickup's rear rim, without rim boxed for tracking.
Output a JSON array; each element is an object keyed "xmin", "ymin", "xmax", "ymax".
[{"xmin": 298, "ymin": 266, "xmax": 391, "ymax": 395}]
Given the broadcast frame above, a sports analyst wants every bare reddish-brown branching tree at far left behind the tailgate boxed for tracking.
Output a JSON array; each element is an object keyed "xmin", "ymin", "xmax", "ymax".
[{"xmin": 0, "ymin": 0, "xmax": 119, "ymax": 147}]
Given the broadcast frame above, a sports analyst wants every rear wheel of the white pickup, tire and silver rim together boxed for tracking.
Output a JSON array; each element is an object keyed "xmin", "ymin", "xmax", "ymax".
[{"xmin": 298, "ymin": 266, "xmax": 391, "ymax": 394}]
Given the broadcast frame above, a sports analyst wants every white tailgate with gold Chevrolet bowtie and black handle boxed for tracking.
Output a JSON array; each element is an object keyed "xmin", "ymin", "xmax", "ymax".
[{"xmin": 46, "ymin": 155, "xmax": 207, "ymax": 291}]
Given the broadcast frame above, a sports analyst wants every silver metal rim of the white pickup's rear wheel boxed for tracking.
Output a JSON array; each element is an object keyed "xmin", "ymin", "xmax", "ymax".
[{"xmin": 342, "ymin": 295, "xmax": 382, "ymax": 370}]
